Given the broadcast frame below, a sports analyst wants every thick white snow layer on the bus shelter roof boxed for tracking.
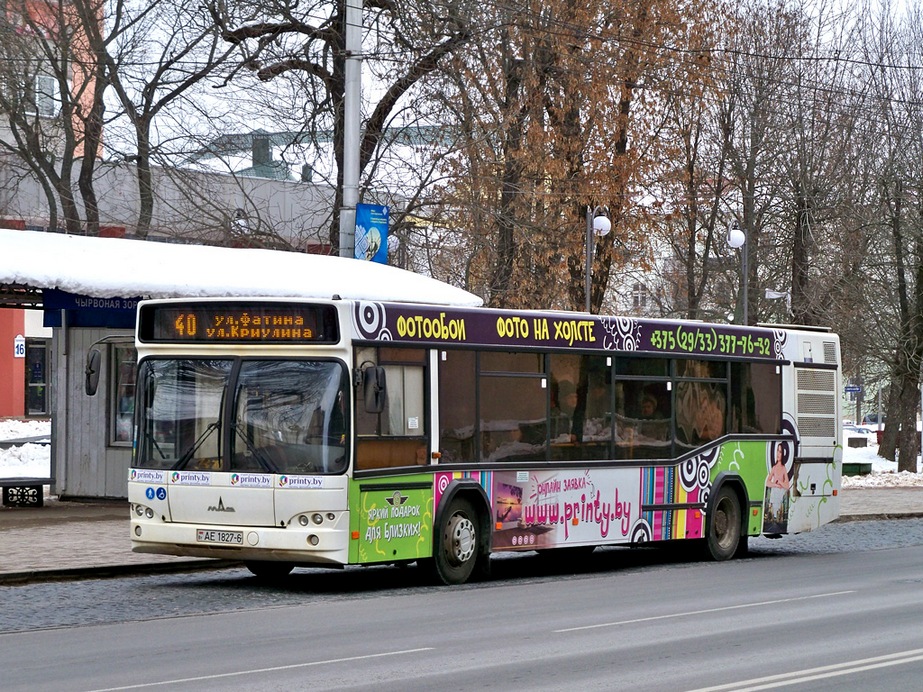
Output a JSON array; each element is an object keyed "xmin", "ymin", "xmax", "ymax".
[{"xmin": 0, "ymin": 229, "xmax": 483, "ymax": 306}]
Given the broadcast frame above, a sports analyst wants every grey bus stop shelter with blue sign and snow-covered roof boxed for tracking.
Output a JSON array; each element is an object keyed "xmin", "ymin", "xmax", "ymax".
[{"xmin": 0, "ymin": 229, "xmax": 481, "ymax": 499}]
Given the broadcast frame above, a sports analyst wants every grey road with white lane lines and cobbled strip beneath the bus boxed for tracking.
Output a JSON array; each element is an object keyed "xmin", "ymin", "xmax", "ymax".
[{"xmin": 0, "ymin": 519, "xmax": 923, "ymax": 692}]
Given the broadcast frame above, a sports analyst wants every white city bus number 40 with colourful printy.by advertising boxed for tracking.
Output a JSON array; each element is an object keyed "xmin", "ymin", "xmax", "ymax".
[{"xmin": 122, "ymin": 297, "xmax": 842, "ymax": 584}]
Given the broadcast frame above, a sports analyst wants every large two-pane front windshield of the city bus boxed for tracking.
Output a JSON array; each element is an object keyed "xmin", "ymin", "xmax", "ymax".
[{"xmin": 134, "ymin": 358, "xmax": 349, "ymax": 474}]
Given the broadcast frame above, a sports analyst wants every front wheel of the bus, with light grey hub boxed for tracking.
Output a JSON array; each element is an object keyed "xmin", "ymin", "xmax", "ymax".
[{"xmin": 430, "ymin": 497, "xmax": 487, "ymax": 585}]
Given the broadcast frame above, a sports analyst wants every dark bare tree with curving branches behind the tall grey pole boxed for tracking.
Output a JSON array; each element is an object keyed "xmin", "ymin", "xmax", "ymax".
[{"xmin": 209, "ymin": 0, "xmax": 471, "ymax": 248}]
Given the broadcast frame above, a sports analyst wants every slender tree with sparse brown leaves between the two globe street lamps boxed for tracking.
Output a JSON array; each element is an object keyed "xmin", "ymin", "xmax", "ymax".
[{"xmin": 626, "ymin": 1, "xmax": 739, "ymax": 319}]
